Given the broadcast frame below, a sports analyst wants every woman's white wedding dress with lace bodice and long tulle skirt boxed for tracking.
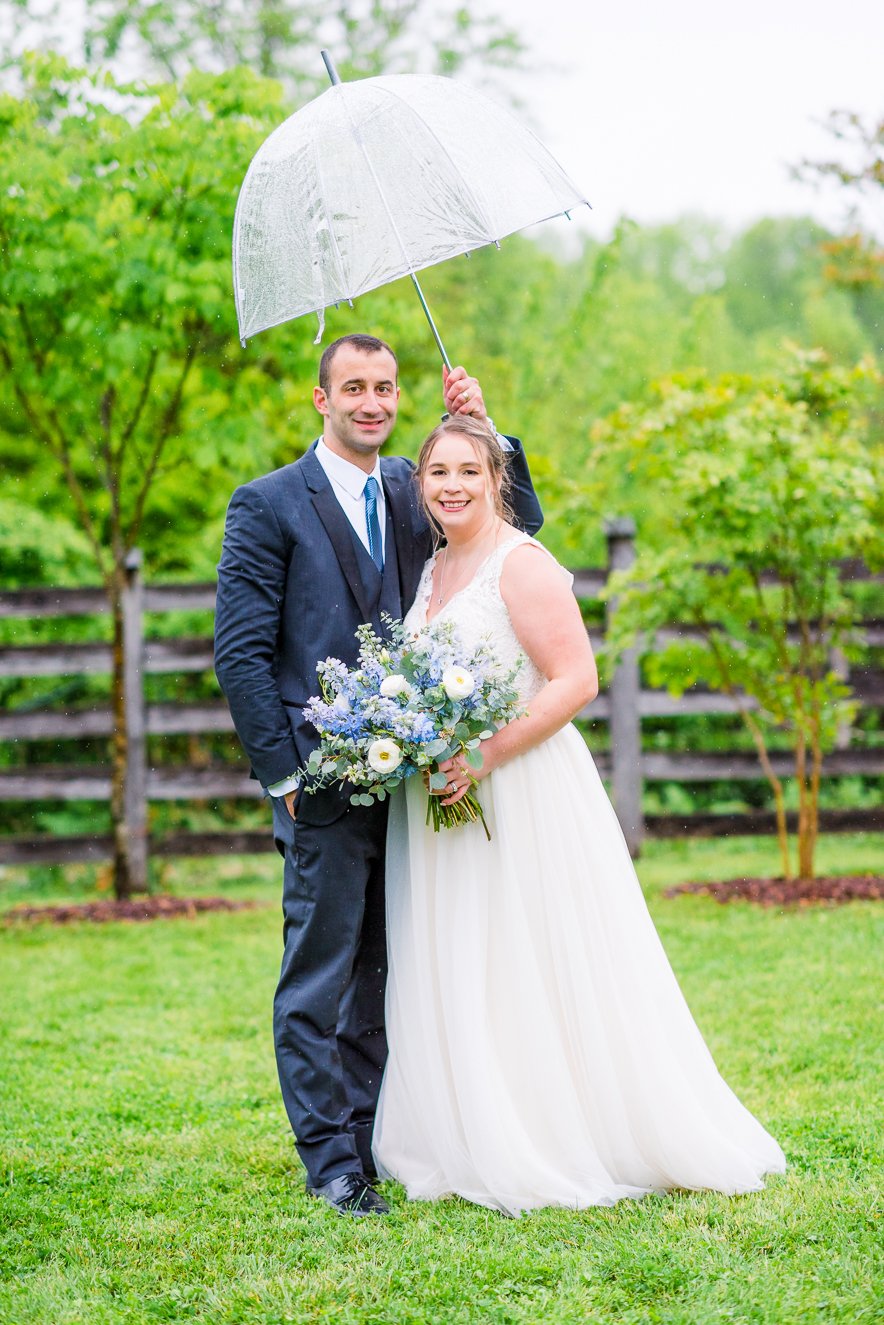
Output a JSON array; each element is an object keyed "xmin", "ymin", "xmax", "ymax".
[{"xmin": 374, "ymin": 534, "xmax": 786, "ymax": 1214}]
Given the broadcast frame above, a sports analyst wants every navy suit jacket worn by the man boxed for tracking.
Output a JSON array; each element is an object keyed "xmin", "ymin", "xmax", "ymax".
[{"xmin": 215, "ymin": 439, "xmax": 543, "ymax": 823}]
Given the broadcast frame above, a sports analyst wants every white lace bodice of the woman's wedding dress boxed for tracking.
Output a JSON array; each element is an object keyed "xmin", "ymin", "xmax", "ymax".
[{"xmin": 406, "ymin": 534, "xmax": 569, "ymax": 704}]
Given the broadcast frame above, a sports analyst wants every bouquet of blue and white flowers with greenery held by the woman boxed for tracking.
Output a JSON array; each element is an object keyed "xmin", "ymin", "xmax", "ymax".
[{"xmin": 302, "ymin": 621, "xmax": 521, "ymax": 839}]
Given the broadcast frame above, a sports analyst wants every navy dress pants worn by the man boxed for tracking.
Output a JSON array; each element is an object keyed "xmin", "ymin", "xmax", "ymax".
[{"xmin": 273, "ymin": 799, "xmax": 387, "ymax": 1187}]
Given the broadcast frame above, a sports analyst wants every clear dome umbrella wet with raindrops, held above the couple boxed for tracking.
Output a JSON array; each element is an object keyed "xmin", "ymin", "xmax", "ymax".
[{"xmin": 233, "ymin": 50, "xmax": 588, "ymax": 364}]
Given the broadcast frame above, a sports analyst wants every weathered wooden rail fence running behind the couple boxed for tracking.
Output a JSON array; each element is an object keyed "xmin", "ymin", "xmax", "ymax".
[{"xmin": 0, "ymin": 521, "xmax": 884, "ymax": 864}]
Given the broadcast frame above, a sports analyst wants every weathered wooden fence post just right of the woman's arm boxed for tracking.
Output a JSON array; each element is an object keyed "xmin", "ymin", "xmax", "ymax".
[{"xmin": 604, "ymin": 517, "xmax": 644, "ymax": 857}]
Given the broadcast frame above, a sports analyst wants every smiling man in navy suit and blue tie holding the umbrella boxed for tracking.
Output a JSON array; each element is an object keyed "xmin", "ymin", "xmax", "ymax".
[{"xmin": 215, "ymin": 335, "xmax": 542, "ymax": 1215}]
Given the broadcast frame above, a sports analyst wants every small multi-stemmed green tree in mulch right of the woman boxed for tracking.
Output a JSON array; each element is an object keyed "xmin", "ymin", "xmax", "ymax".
[{"xmin": 592, "ymin": 351, "xmax": 884, "ymax": 877}]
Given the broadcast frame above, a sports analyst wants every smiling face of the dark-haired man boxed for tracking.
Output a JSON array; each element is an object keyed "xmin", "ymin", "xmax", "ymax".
[{"xmin": 313, "ymin": 345, "xmax": 399, "ymax": 470}]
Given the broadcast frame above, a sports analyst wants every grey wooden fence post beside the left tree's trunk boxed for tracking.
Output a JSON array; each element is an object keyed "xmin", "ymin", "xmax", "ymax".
[{"xmin": 123, "ymin": 547, "xmax": 147, "ymax": 892}]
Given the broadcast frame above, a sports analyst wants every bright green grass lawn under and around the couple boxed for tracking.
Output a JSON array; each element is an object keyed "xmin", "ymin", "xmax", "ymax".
[{"xmin": 0, "ymin": 836, "xmax": 884, "ymax": 1325}]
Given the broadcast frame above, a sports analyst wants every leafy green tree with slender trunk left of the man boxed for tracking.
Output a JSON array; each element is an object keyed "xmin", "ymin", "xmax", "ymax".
[{"xmin": 0, "ymin": 57, "xmax": 314, "ymax": 896}]
